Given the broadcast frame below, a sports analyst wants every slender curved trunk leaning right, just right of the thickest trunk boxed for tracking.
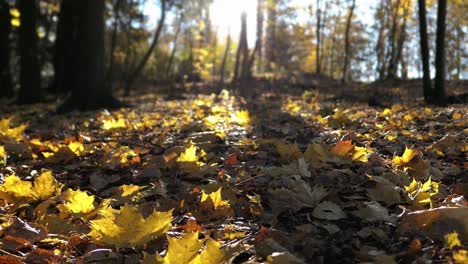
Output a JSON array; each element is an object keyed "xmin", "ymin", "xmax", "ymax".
[{"xmin": 125, "ymin": 0, "xmax": 167, "ymax": 96}]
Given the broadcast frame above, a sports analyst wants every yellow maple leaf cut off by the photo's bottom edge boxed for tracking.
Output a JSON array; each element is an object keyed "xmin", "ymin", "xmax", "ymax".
[{"xmin": 143, "ymin": 232, "xmax": 226, "ymax": 264}]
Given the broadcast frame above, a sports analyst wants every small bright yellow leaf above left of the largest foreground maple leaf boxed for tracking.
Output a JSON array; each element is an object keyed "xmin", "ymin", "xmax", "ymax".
[{"xmin": 57, "ymin": 189, "xmax": 94, "ymax": 214}]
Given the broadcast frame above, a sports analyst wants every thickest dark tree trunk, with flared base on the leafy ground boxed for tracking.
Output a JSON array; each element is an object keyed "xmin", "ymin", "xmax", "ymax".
[{"xmin": 59, "ymin": 0, "xmax": 121, "ymax": 112}]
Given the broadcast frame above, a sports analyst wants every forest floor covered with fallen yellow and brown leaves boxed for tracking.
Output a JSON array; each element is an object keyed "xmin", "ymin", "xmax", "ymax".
[{"xmin": 0, "ymin": 81, "xmax": 468, "ymax": 264}]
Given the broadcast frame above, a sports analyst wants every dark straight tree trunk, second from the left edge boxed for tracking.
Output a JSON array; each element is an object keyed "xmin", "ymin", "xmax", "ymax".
[{"xmin": 18, "ymin": 0, "xmax": 41, "ymax": 104}]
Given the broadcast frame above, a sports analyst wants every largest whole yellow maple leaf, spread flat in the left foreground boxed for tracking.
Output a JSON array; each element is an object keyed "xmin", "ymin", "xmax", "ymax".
[{"xmin": 88, "ymin": 204, "xmax": 172, "ymax": 248}]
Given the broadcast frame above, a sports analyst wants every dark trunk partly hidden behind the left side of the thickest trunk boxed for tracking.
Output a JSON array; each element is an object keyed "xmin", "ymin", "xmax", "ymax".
[{"xmin": 52, "ymin": 0, "xmax": 76, "ymax": 94}]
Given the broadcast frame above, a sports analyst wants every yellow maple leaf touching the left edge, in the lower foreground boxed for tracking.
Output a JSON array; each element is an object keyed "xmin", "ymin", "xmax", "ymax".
[{"xmin": 0, "ymin": 171, "xmax": 62, "ymax": 203}]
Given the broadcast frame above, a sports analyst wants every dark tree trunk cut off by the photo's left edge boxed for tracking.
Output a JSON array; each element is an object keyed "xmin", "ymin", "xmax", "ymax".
[{"xmin": 0, "ymin": 0, "xmax": 13, "ymax": 98}]
